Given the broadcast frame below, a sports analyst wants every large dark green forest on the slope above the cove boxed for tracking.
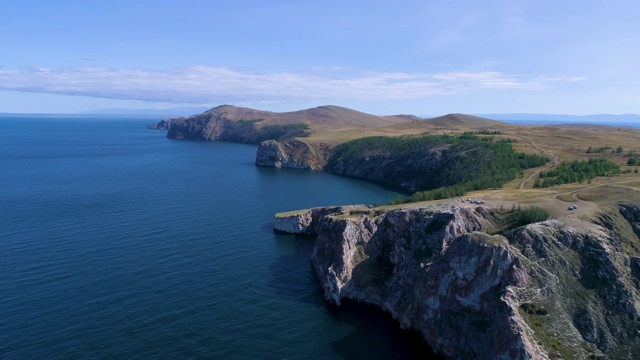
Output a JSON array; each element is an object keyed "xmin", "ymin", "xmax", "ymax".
[{"xmin": 326, "ymin": 133, "xmax": 549, "ymax": 203}]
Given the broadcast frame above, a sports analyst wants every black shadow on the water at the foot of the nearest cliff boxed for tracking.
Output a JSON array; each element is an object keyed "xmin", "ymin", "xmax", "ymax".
[{"xmin": 327, "ymin": 300, "xmax": 445, "ymax": 360}]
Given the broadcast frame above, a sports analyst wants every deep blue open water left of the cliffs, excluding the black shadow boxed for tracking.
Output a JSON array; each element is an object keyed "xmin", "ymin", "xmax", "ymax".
[{"xmin": 0, "ymin": 117, "xmax": 440, "ymax": 359}]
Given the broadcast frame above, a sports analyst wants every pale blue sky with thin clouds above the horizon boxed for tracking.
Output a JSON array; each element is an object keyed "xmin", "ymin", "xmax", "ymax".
[{"xmin": 0, "ymin": 0, "xmax": 640, "ymax": 116}]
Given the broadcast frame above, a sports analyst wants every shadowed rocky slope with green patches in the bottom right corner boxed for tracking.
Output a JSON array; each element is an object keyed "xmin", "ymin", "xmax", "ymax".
[{"xmin": 509, "ymin": 220, "xmax": 640, "ymax": 359}]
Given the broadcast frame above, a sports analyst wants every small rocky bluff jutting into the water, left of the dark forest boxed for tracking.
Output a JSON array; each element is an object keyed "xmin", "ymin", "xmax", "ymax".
[{"xmin": 256, "ymin": 140, "xmax": 329, "ymax": 170}]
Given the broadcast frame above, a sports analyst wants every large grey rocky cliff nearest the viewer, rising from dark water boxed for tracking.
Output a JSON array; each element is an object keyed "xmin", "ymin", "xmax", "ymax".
[{"xmin": 275, "ymin": 205, "xmax": 640, "ymax": 359}]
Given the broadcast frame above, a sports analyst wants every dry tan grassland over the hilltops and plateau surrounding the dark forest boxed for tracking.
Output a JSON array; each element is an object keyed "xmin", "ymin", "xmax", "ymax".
[{"xmin": 216, "ymin": 106, "xmax": 640, "ymax": 217}]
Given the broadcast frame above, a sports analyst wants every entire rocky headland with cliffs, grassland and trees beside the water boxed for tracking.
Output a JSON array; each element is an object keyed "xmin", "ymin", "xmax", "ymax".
[{"xmin": 151, "ymin": 106, "xmax": 640, "ymax": 359}]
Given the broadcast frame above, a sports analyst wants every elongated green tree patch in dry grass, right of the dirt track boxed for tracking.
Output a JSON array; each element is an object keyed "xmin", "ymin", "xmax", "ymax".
[{"xmin": 533, "ymin": 159, "xmax": 620, "ymax": 188}]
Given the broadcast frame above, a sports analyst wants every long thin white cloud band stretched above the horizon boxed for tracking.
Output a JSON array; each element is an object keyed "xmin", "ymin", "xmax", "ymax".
[{"xmin": 0, "ymin": 66, "xmax": 583, "ymax": 104}]
